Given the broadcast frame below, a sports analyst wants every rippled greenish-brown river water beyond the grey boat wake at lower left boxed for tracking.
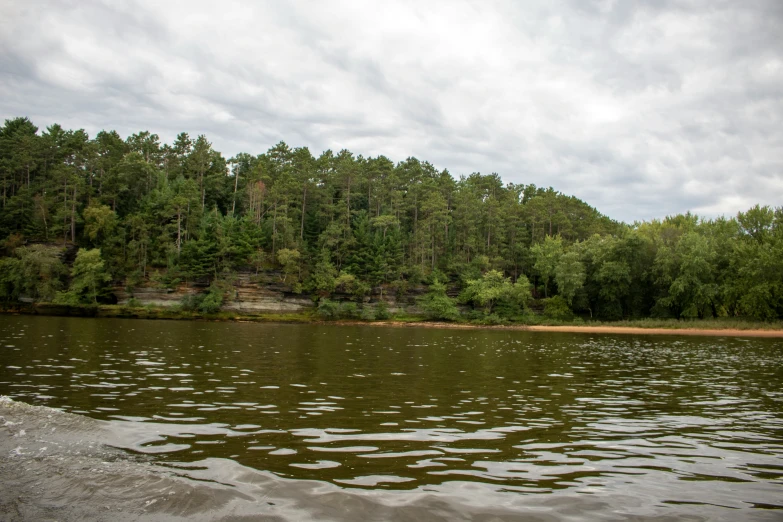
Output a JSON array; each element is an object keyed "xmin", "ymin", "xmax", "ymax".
[{"xmin": 0, "ymin": 316, "xmax": 783, "ymax": 520}]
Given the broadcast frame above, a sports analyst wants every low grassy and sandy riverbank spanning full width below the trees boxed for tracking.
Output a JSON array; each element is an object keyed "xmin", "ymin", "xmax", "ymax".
[{"xmin": 0, "ymin": 303, "xmax": 783, "ymax": 338}]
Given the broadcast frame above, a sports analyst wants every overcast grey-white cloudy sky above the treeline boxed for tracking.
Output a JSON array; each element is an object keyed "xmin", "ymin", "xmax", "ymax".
[{"xmin": 0, "ymin": 0, "xmax": 783, "ymax": 222}]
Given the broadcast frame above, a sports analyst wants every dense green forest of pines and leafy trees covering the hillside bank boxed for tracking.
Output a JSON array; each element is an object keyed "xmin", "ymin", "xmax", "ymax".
[{"xmin": 0, "ymin": 117, "xmax": 783, "ymax": 323}]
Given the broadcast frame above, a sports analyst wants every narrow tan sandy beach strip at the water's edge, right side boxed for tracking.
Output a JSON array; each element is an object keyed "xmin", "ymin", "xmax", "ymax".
[{"xmin": 319, "ymin": 321, "xmax": 783, "ymax": 338}]
